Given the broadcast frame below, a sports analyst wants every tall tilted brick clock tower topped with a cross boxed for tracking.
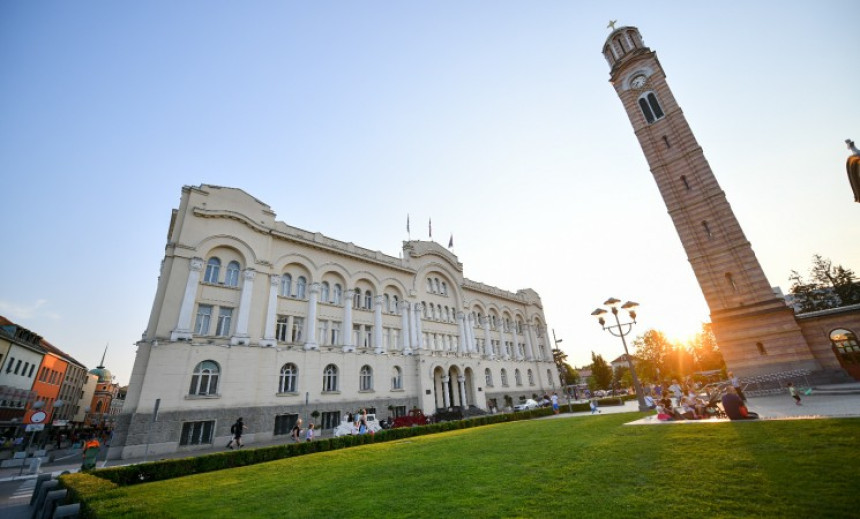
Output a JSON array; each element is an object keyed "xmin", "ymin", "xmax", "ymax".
[{"xmin": 603, "ymin": 27, "xmax": 822, "ymax": 377}]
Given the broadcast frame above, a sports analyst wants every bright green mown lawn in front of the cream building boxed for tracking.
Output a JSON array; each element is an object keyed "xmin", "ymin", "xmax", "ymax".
[{"xmin": 85, "ymin": 414, "xmax": 860, "ymax": 519}]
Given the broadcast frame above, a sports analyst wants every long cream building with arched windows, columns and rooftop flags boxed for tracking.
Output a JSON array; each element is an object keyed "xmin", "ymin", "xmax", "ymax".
[{"xmin": 110, "ymin": 185, "xmax": 558, "ymax": 458}]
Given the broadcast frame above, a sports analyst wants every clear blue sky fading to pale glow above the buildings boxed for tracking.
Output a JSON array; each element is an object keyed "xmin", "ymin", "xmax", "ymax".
[{"xmin": 0, "ymin": 0, "xmax": 860, "ymax": 383}]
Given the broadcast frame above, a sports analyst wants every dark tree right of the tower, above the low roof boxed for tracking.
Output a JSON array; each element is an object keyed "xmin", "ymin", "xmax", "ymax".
[{"xmin": 788, "ymin": 254, "xmax": 860, "ymax": 313}]
